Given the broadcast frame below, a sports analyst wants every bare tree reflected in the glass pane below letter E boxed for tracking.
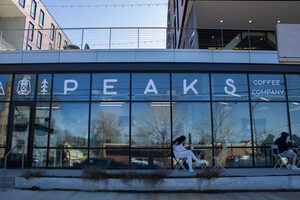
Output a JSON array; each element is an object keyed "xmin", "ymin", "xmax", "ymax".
[{"xmin": 92, "ymin": 110, "xmax": 123, "ymax": 146}]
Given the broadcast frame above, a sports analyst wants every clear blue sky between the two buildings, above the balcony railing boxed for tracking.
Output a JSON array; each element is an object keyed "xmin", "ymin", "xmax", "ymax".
[{"xmin": 42, "ymin": 0, "xmax": 168, "ymax": 28}]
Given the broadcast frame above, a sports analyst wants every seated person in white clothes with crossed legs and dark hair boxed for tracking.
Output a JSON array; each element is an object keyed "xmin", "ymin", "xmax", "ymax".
[{"xmin": 172, "ymin": 135, "xmax": 204, "ymax": 172}]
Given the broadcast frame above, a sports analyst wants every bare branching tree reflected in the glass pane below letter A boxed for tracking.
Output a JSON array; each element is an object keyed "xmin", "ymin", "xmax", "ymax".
[{"xmin": 133, "ymin": 104, "xmax": 172, "ymax": 146}]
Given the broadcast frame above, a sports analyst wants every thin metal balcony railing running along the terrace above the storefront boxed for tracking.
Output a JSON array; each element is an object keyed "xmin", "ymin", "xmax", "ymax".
[{"xmin": 3, "ymin": 27, "xmax": 277, "ymax": 50}]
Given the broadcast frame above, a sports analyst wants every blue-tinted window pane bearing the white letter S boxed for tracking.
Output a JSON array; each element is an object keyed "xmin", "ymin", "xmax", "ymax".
[{"xmin": 211, "ymin": 74, "xmax": 248, "ymax": 101}]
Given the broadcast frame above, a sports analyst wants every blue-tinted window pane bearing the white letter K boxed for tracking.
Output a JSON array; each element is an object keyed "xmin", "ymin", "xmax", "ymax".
[{"xmin": 172, "ymin": 73, "xmax": 210, "ymax": 101}]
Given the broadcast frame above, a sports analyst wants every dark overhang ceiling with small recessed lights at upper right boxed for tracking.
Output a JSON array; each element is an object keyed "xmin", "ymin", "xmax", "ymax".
[{"xmin": 190, "ymin": 1, "xmax": 300, "ymax": 30}]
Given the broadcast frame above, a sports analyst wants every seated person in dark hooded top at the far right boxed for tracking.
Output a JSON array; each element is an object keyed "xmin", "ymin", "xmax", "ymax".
[{"xmin": 274, "ymin": 132, "xmax": 300, "ymax": 170}]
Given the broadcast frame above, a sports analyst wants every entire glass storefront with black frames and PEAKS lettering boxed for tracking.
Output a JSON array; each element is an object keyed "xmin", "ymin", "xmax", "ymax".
[{"xmin": 0, "ymin": 63, "xmax": 300, "ymax": 169}]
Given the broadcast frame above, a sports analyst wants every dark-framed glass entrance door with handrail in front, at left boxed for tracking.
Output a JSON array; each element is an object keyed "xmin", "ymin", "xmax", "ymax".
[{"xmin": 8, "ymin": 102, "xmax": 34, "ymax": 168}]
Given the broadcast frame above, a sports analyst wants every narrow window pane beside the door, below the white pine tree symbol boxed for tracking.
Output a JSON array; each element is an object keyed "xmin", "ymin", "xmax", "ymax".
[{"xmin": 34, "ymin": 103, "xmax": 53, "ymax": 147}]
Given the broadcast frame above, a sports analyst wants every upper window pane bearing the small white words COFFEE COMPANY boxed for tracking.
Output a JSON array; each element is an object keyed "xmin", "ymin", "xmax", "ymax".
[{"xmin": 249, "ymin": 74, "xmax": 285, "ymax": 101}]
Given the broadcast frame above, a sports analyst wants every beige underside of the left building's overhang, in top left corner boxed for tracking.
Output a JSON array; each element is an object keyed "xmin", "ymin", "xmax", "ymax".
[{"xmin": 0, "ymin": 0, "xmax": 24, "ymax": 17}]
